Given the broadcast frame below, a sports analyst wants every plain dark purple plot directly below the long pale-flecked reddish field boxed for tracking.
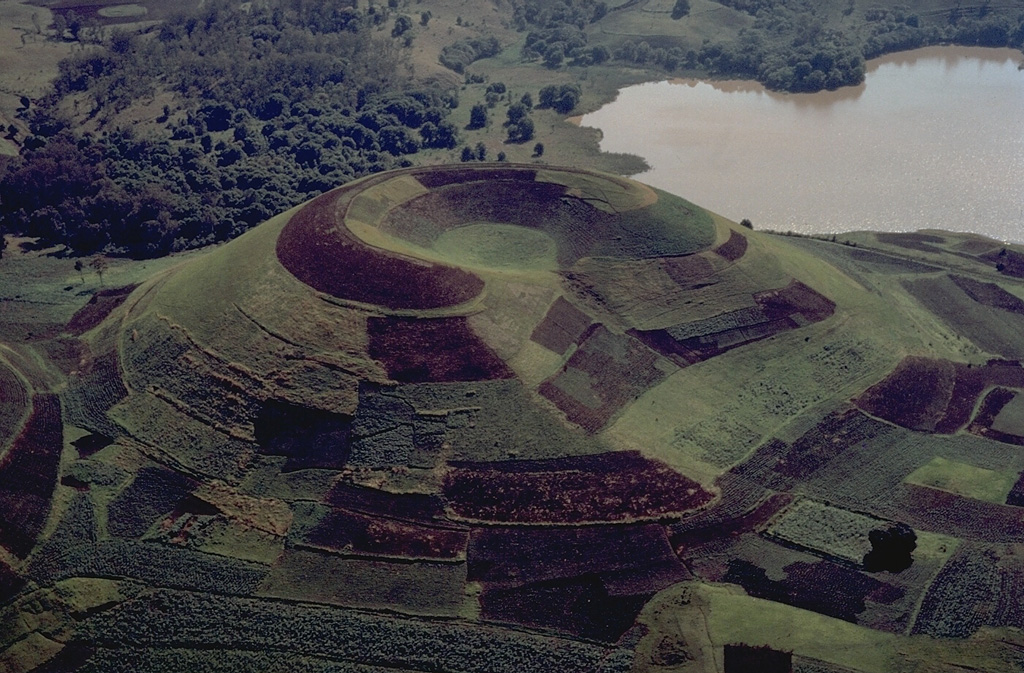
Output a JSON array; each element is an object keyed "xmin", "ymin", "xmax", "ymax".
[{"xmin": 467, "ymin": 523, "xmax": 688, "ymax": 593}]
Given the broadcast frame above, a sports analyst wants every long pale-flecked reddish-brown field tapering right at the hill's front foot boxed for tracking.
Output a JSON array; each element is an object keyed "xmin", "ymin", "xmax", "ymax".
[{"xmin": 443, "ymin": 451, "xmax": 712, "ymax": 523}]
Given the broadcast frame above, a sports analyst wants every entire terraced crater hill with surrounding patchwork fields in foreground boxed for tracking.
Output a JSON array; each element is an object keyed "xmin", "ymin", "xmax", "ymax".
[{"xmin": 0, "ymin": 163, "xmax": 1024, "ymax": 673}]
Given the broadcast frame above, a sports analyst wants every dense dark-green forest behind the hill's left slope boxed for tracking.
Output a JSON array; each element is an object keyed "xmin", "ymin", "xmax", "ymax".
[{"xmin": 0, "ymin": 0, "xmax": 459, "ymax": 257}]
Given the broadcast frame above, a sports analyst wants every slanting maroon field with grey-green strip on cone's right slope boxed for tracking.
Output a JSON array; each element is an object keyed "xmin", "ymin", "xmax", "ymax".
[{"xmin": 630, "ymin": 281, "xmax": 836, "ymax": 367}]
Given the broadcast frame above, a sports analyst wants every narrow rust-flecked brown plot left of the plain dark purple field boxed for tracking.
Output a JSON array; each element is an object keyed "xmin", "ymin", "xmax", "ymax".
[{"xmin": 304, "ymin": 509, "xmax": 468, "ymax": 560}]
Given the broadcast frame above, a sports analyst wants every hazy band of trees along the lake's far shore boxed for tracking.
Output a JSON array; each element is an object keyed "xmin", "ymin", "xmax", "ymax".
[{"xmin": 515, "ymin": 0, "xmax": 1024, "ymax": 92}]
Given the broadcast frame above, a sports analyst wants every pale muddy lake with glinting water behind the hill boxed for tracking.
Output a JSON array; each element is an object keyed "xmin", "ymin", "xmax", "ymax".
[{"xmin": 581, "ymin": 47, "xmax": 1024, "ymax": 242}]
